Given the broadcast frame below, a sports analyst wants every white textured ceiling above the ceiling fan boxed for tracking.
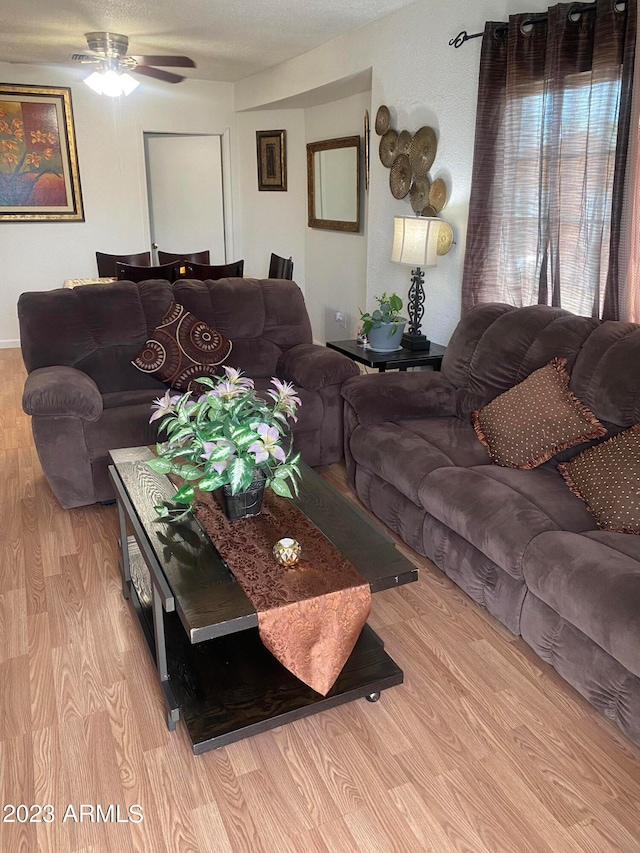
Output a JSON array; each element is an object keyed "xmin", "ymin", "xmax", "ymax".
[{"xmin": 0, "ymin": 0, "xmax": 415, "ymax": 82}]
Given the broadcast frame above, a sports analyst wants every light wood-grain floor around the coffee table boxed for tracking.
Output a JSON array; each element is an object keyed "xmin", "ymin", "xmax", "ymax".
[{"xmin": 0, "ymin": 350, "xmax": 640, "ymax": 853}]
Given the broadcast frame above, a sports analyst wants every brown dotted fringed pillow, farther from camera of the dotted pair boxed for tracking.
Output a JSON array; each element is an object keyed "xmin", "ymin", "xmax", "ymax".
[{"xmin": 471, "ymin": 358, "xmax": 606, "ymax": 468}]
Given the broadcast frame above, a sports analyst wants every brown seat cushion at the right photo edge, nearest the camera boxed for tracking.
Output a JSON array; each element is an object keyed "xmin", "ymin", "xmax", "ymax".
[{"xmin": 523, "ymin": 532, "xmax": 640, "ymax": 676}]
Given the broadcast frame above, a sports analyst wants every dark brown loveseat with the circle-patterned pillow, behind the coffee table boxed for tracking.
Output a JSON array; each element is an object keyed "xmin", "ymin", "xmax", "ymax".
[{"xmin": 18, "ymin": 278, "xmax": 358, "ymax": 508}]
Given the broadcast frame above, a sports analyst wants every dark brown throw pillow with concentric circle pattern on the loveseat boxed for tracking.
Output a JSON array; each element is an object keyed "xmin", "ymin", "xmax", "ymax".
[{"xmin": 131, "ymin": 302, "xmax": 232, "ymax": 391}]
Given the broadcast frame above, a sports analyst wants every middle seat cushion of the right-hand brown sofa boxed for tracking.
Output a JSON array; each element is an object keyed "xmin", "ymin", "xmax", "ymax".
[{"xmin": 420, "ymin": 465, "xmax": 596, "ymax": 579}]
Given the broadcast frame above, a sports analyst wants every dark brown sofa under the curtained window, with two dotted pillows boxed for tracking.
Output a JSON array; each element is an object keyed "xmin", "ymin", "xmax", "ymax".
[{"xmin": 342, "ymin": 304, "xmax": 640, "ymax": 743}]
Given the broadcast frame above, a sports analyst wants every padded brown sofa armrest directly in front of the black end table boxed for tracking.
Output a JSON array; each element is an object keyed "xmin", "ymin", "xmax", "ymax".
[{"xmin": 341, "ymin": 371, "xmax": 456, "ymax": 424}]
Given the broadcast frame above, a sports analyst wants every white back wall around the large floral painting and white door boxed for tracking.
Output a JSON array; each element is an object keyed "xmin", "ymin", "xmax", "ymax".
[{"xmin": 0, "ymin": 63, "xmax": 235, "ymax": 346}]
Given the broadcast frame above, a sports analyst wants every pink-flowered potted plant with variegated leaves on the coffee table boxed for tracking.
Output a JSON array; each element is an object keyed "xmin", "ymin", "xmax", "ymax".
[{"xmin": 149, "ymin": 367, "xmax": 301, "ymax": 521}]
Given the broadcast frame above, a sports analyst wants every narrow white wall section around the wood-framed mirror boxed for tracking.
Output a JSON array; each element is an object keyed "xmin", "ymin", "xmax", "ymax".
[{"xmin": 303, "ymin": 92, "xmax": 371, "ymax": 343}]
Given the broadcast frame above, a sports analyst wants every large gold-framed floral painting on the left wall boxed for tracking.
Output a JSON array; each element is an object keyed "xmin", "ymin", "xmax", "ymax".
[{"xmin": 0, "ymin": 83, "xmax": 84, "ymax": 222}]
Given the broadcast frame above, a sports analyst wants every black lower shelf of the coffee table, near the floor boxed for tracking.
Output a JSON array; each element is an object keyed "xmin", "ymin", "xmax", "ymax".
[{"xmin": 127, "ymin": 582, "xmax": 403, "ymax": 755}]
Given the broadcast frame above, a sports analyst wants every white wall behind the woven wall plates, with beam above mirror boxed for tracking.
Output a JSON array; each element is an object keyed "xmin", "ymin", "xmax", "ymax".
[{"xmin": 235, "ymin": 0, "xmax": 549, "ymax": 343}]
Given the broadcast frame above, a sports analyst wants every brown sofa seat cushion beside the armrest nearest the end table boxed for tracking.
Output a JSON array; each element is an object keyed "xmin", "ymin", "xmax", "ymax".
[{"xmin": 349, "ymin": 416, "xmax": 490, "ymax": 506}]
